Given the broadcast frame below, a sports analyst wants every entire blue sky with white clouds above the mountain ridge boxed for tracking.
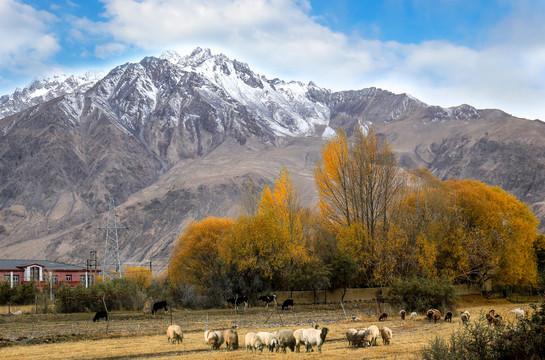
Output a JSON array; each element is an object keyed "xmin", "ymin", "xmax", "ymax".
[{"xmin": 0, "ymin": 0, "xmax": 545, "ymax": 120}]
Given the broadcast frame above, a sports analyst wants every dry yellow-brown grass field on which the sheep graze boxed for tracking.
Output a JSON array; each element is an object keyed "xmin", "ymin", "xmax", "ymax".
[{"xmin": 0, "ymin": 296, "xmax": 530, "ymax": 360}]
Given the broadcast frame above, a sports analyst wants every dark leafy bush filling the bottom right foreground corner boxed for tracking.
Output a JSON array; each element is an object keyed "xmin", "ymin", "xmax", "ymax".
[{"xmin": 422, "ymin": 304, "xmax": 545, "ymax": 360}]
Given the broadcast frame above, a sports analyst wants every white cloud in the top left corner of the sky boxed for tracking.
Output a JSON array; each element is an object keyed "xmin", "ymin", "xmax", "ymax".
[{"xmin": 0, "ymin": 0, "xmax": 60, "ymax": 73}]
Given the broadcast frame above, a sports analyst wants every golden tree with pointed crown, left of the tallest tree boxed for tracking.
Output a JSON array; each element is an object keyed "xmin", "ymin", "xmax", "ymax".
[{"xmin": 221, "ymin": 169, "xmax": 308, "ymax": 288}]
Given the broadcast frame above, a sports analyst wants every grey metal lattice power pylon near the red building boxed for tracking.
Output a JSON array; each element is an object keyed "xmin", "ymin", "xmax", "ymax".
[{"xmin": 99, "ymin": 197, "xmax": 128, "ymax": 282}]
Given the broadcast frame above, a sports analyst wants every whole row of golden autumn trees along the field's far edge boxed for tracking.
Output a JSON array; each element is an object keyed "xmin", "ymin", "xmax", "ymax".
[{"xmin": 169, "ymin": 130, "xmax": 543, "ymax": 302}]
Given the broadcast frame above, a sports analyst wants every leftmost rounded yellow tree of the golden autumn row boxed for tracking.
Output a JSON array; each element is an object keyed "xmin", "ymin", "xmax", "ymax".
[{"xmin": 169, "ymin": 217, "xmax": 233, "ymax": 289}]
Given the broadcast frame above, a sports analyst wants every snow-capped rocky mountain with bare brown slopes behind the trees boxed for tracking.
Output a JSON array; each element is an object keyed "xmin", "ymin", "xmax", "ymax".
[{"xmin": 0, "ymin": 48, "xmax": 545, "ymax": 269}]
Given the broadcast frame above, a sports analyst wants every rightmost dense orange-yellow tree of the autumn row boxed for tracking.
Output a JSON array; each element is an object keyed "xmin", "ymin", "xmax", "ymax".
[{"xmin": 447, "ymin": 180, "xmax": 538, "ymax": 286}]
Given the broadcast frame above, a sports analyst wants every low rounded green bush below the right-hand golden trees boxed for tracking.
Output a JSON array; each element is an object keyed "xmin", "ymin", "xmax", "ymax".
[{"xmin": 385, "ymin": 278, "xmax": 458, "ymax": 312}]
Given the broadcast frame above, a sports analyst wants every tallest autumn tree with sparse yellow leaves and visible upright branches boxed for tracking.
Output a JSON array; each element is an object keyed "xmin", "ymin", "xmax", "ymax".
[{"xmin": 314, "ymin": 128, "xmax": 403, "ymax": 285}]
